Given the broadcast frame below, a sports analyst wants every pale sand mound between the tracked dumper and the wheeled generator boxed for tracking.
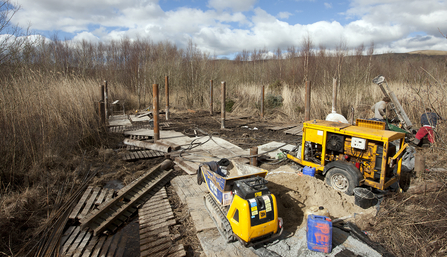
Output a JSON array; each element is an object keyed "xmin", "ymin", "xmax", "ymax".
[{"xmin": 267, "ymin": 166, "xmax": 375, "ymax": 231}]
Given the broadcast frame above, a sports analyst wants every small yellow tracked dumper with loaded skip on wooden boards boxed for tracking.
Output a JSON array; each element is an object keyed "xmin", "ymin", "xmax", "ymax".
[{"xmin": 197, "ymin": 163, "xmax": 283, "ymax": 246}]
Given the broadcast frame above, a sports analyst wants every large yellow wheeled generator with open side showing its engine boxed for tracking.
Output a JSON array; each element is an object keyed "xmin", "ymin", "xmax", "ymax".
[{"xmin": 287, "ymin": 119, "xmax": 407, "ymax": 195}]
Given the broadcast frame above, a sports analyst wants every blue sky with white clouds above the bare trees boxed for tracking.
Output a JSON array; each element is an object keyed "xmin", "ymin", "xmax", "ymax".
[{"xmin": 6, "ymin": 0, "xmax": 447, "ymax": 56}]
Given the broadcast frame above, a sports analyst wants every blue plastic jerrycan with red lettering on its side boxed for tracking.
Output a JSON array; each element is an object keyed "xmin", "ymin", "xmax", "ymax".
[{"xmin": 306, "ymin": 214, "xmax": 332, "ymax": 253}]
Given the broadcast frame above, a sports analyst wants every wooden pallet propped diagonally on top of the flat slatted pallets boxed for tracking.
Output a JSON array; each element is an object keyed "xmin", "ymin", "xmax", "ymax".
[{"xmin": 79, "ymin": 164, "xmax": 172, "ymax": 236}]
